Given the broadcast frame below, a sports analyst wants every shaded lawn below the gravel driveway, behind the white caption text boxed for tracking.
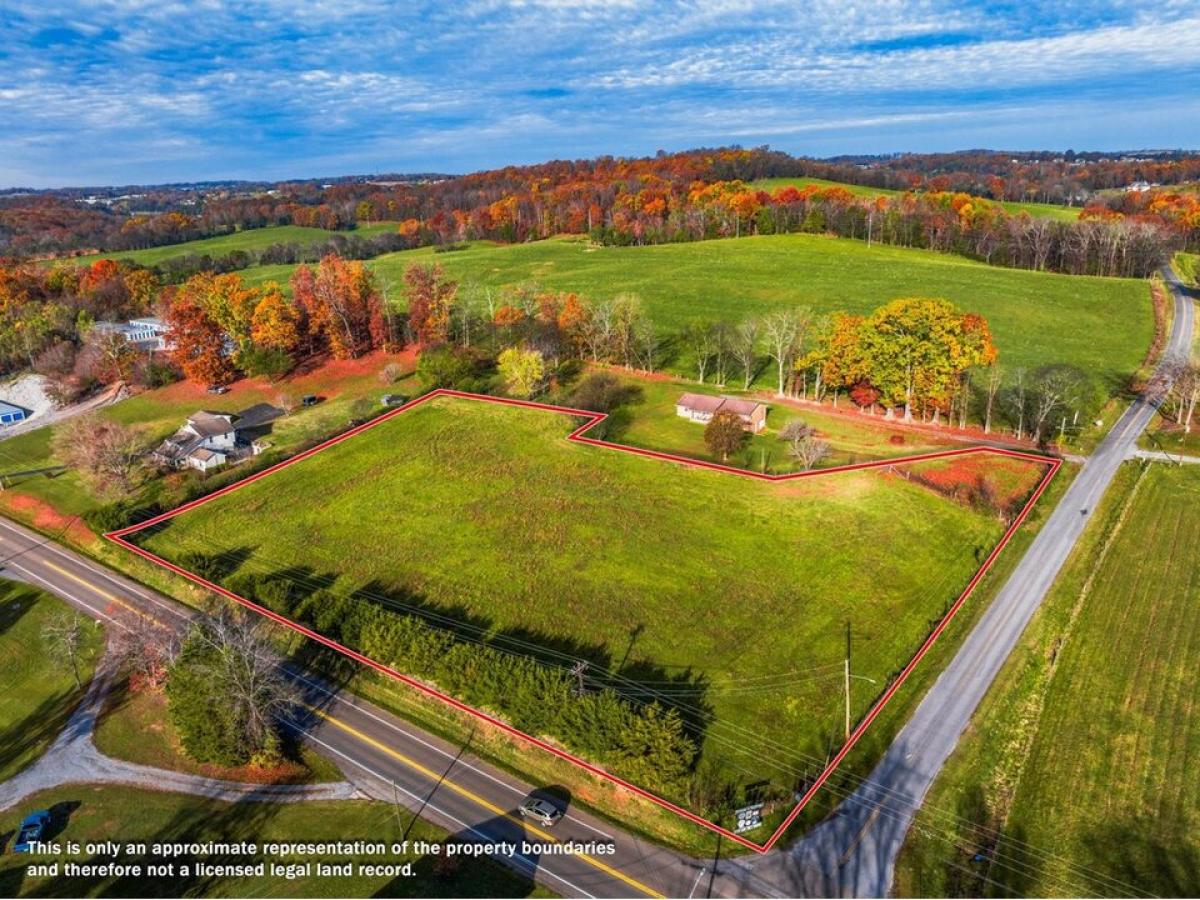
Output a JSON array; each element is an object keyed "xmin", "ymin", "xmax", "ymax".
[{"xmin": 0, "ymin": 785, "xmax": 553, "ymax": 898}]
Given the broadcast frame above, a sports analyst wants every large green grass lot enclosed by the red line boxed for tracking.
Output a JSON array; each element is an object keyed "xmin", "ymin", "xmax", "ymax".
[{"xmin": 138, "ymin": 397, "xmax": 1022, "ymax": 779}]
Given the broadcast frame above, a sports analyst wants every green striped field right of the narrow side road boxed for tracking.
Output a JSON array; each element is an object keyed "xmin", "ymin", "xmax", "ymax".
[{"xmin": 898, "ymin": 463, "xmax": 1200, "ymax": 896}]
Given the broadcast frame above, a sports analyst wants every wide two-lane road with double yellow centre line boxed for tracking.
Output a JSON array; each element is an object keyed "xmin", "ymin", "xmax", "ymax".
[{"xmin": 0, "ymin": 518, "xmax": 774, "ymax": 898}]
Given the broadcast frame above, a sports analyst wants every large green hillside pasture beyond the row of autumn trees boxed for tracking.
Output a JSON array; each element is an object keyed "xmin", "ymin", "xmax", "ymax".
[{"xmin": 244, "ymin": 234, "xmax": 1153, "ymax": 396}]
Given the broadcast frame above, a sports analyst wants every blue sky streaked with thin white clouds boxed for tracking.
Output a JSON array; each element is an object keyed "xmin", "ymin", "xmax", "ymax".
[{"xmin": 0, "ymin": 0, "xmax": 1200, "ymax": 186}]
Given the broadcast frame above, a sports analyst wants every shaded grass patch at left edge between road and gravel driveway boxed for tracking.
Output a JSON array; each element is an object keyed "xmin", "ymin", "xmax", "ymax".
[{"xmin": 0, "ymin": 581, "xmax": 103, "ymax": 782}]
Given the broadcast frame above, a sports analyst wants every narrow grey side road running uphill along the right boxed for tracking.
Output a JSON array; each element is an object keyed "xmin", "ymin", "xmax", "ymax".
[{"xmin": 744, "ymin": 264, "xmax": 1194, "ymax": 896}]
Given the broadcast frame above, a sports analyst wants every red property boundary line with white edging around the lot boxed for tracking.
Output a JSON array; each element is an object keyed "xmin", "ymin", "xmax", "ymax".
[{"xmin": 104, "ymin": 389, "xmax": 1062, "ymax": 853}]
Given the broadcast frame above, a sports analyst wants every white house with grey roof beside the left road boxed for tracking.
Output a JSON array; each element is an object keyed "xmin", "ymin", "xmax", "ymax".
[{"xmin": 151, "ymin": 403, "xmax": 283, "ymax": 472}]
